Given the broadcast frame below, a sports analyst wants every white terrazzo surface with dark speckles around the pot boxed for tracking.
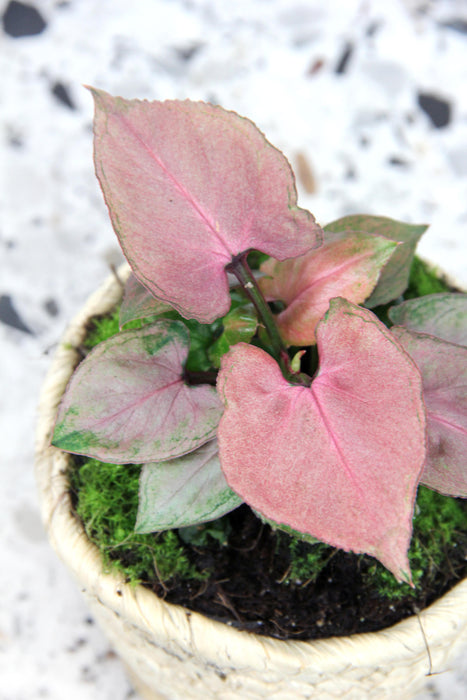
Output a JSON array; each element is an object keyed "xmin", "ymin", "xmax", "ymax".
[{"xmin": 0, "ymin": 0, "xmax": 467, "ymax": 700}]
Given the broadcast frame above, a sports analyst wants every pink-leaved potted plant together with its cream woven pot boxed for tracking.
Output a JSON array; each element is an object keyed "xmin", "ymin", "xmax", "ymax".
[{"xmin": 37, "ymin": 89, "xmax": 467, "ymax": 698}]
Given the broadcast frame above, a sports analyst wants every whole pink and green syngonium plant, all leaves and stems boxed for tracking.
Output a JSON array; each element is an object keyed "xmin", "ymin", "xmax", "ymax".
[{"xmin": 53, "ymin": 89, "xmax": 467, "ymax": 582}]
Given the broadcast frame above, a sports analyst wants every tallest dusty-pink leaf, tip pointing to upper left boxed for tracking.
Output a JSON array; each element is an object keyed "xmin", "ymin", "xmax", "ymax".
[{"xmin": 88, "ymin": 89, "xmax": 321, "ymax": 323}]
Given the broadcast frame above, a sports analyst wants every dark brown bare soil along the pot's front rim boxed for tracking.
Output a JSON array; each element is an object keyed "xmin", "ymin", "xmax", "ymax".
[{"xmin": 136, "ymin": 506, "xmax": 467, "ymax": 639}]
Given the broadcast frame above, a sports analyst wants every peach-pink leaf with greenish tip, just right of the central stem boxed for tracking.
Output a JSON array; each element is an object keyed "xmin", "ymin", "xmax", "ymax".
[{"xmin": 259, "ymin": 229, "xmax": 397, "ymax": 346}]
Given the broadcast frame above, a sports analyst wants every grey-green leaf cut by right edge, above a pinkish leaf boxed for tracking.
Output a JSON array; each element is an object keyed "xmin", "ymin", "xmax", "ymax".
[{"xmin": 388, "ymin": 294, "xmax": 467, "ymax": 345}]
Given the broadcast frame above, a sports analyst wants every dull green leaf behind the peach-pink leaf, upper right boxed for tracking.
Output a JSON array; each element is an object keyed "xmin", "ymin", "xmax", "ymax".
[{"xmin": 325, "ymin": 214, "xmax": 428, "ymax": 308}]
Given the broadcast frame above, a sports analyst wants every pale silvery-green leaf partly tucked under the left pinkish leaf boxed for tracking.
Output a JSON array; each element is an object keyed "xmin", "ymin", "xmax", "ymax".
[{"xmin": 135, "ymin": 440, "xmax": 242, "ymax": 532}]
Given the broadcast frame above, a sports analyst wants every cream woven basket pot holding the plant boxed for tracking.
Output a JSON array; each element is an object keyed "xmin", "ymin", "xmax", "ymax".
[{"xmin": 36, "ymin": 268, "xmax": 467, "ymax": 700}]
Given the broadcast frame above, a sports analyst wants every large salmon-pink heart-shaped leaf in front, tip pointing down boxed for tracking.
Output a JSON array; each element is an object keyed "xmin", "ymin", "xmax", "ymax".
[{"xmin": 218, "ymin": 299, "xmax": 425, "ymax": 580}]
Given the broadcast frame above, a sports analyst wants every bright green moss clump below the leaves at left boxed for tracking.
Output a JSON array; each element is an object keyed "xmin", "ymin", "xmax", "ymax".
[{"xmin": 70, "ymin": 459, "xmax": 206, "ymax": 584}]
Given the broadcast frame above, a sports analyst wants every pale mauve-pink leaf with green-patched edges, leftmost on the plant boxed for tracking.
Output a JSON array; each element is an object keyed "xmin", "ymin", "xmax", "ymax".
[{"xmin": 53, "ymin": 320, "xmax": 222, "ymax": 464}]
